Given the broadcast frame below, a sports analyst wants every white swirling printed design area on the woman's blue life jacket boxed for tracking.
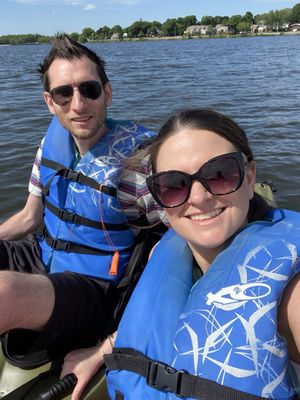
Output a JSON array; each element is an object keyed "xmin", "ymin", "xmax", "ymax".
[{"xmin": 172, "ymin": 240, "xmax": 298, "ymax": 398}]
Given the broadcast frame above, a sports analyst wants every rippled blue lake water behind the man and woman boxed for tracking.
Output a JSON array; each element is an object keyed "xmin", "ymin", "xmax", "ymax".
[{"xmin": 0, "ymin": 36, "xmax": 300, "ymax": 220}]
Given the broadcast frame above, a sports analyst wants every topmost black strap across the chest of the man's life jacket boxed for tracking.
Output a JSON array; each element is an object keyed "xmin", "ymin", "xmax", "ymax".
[{"xmin": 41, "ymin": 158, "xmax": 117, "ymax": 197}]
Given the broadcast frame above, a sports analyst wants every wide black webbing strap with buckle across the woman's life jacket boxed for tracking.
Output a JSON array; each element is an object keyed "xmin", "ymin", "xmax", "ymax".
[{"xmin": 104, "ymin": 348, "xmax": 265, "ymax": 400}]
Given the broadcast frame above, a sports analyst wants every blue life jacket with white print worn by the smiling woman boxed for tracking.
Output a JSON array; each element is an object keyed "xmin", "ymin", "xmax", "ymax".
[{"xmin": 106, "ymin": 210, "xmax": 300, "ymax": 400}]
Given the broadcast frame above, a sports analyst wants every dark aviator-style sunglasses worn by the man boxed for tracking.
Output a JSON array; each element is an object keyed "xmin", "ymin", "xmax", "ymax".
[{"xmin": 50, "ymin": 81, "xmax": 102, "ymax": 106}]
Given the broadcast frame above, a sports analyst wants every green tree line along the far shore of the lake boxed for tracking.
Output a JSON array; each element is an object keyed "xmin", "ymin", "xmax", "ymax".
[{"xmin": 0, "ymin": 3, "xmax": 300, "ymax": 45}]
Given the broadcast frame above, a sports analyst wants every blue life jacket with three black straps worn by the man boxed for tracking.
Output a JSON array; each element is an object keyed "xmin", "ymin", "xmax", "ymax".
[{"xmin": 40, "ymin": 117, "xmax": 154, "ymax": 282}]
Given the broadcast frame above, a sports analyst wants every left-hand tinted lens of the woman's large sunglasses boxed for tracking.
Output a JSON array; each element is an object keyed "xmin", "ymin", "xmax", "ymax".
[{"xmin": 152, "ymin": 172, "xmax": 190, "ymax": 207}]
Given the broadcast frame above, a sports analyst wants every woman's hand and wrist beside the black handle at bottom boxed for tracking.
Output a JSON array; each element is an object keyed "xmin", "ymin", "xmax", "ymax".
[{"xmin": 61, "ymin": 334, "xmax": 115, "ymax": 400}]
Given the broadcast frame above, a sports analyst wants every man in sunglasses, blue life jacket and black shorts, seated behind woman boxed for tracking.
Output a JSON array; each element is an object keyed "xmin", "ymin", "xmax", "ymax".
[{"xmin": 0, "ymin": 34, "xmax": 159, "ymax": 364}]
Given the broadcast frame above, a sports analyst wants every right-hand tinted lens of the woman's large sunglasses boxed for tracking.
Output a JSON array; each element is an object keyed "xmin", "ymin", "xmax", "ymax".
[{"xmin": 201, "ymin": 157, "xmax": 242, "ymax": 195}]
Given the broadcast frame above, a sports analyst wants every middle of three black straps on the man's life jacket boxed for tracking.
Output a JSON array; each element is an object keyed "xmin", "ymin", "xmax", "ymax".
[{"xmin": 44, "ymin": 199, "xmax": 128, "ymax": 231}]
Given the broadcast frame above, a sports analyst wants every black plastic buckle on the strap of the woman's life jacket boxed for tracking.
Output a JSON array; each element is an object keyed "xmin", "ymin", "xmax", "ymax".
[{"xmin": 147, "ymin": 361, "xmax": 186, "ymax": 397}]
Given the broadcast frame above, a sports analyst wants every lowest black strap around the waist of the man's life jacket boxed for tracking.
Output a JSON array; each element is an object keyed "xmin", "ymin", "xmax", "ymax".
[{"xmin": 43, "ymin": 228, "xmax": 113, "ymax": 255}]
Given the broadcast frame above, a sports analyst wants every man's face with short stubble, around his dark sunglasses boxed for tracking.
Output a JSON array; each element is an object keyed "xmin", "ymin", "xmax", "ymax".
[{"xmin": 44, "ymin": 57, "xmax": 112, "ymax": 147}]
